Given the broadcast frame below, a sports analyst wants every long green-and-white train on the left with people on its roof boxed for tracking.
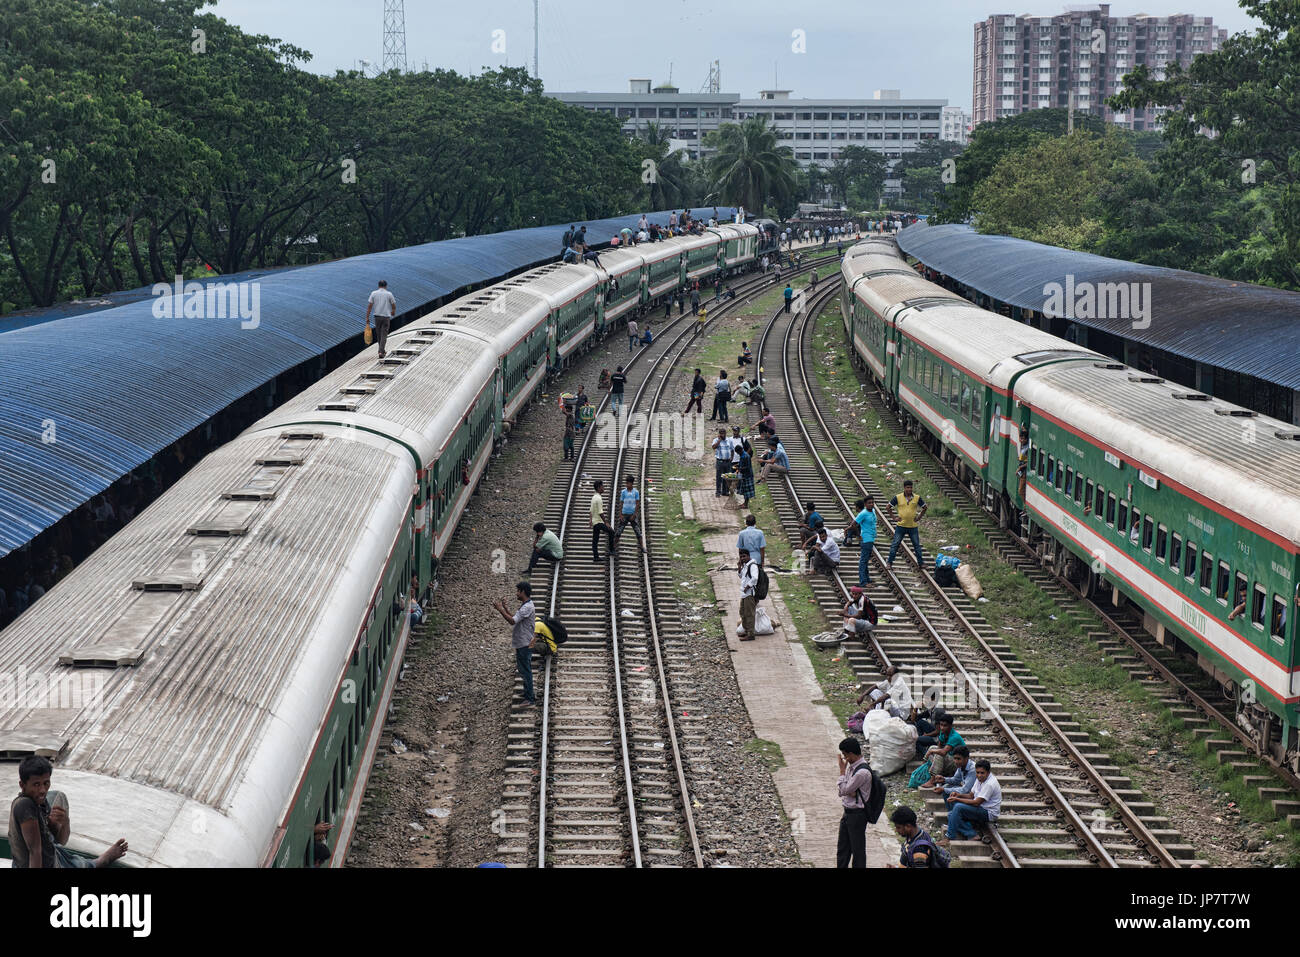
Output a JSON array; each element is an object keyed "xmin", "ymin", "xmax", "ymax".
[{"xmin": 0, "ymin": 224, "xmax": 759, "ymax": 867}]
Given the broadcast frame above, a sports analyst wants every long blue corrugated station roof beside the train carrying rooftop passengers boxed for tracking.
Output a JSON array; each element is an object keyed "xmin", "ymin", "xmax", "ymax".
[{"xmin": 0, "ymin": 207, "xmax": 735, "ymax": 555}]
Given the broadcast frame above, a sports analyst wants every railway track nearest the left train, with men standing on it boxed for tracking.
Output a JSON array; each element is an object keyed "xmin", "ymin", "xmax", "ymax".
[{"xmin": 494, "ymin": 256, "xmax": 811, "ymax": 867}]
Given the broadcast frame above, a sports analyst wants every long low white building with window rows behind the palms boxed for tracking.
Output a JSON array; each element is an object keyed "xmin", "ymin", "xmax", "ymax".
[{"xmin": 547, "ymin": 79, "xmax": 948, "ymax": 166}]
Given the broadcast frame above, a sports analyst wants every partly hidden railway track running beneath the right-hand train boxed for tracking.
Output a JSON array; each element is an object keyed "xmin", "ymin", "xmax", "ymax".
[{"xmin": 821, "ymin": 297, "xmax": 1300, "ymax": 827}]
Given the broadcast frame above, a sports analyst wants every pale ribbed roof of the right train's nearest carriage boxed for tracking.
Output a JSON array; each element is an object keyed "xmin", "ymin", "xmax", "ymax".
[{"xmin": 1015, "ymin": 360, "xmax": 1300, "ymax": 545}]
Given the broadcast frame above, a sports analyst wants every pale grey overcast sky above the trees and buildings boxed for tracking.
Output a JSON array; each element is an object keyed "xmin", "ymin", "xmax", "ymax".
[{"xmin": 213, "ymin": 0, "xmax": 1257, "ymax": 109}]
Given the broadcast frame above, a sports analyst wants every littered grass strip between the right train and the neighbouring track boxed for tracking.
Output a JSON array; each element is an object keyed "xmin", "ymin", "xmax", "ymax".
[{"xmin": 807, "ymin": 297, "xmax": 1300, "ymax": 866}]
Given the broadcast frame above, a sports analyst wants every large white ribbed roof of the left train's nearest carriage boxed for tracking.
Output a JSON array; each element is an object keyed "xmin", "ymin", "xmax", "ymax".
[{"xmin": 0, "ymin": 429, "xmax": 415, "ymax": 865}]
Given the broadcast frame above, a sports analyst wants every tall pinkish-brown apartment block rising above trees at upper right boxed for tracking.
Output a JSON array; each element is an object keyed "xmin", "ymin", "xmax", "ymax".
[{"xmin": 974, "ymin": 4, "xmax": 1227, "ymax": 130}]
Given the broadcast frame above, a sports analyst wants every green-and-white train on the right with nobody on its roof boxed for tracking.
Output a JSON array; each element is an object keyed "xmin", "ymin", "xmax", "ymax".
[{"xmin": 840, "ymin": 239, "xmax": 1300, "ymax": 772}]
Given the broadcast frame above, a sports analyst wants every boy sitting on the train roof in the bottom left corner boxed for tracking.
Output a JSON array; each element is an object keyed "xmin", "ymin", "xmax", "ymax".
[{"xmin": 9, "ymin": 754, "xmax": 129, "ymax": 870}]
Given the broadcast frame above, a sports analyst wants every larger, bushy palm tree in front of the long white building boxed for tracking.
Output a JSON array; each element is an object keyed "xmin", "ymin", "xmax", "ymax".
[{"xmin": 706, "ymin": 117, "xmax": 796, "ymax": 215}]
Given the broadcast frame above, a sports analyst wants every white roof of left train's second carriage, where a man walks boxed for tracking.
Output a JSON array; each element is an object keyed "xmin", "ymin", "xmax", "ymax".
[{"xmin": 252, "ymin": 322, "xmax": 498, "ymax": 467}]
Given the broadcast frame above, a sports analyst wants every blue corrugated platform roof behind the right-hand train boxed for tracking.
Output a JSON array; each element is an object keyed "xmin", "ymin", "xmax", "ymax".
[{"xmin": 898, "ymin": 225, "xmax": 1300, "ymax": 389}]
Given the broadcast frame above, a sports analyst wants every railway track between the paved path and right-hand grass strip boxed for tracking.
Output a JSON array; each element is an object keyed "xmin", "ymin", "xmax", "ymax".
[{"xmin": 759, "ymin": 286, "xmax": 1195, "ymax": 867}]
